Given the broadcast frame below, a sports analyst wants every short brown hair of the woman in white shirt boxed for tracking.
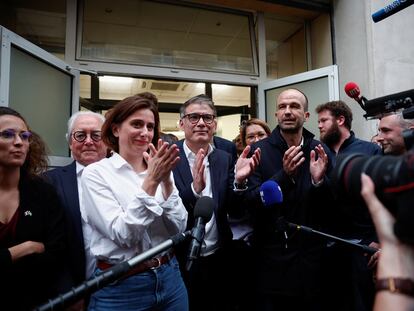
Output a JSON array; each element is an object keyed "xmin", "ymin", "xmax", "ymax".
[{"xmin": 102, "ymin": 92, "xmax": 160, "ymax": 152}]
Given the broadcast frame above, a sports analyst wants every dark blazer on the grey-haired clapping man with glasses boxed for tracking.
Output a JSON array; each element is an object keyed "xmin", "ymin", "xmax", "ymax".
[{"xmin": 173, "ymin": 140, "xmax": 237, "ymax": 243}]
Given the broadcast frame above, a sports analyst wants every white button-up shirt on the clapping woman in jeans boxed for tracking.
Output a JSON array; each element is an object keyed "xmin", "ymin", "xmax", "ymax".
[{"xmin": 82, "ymin": 152, "xmax": 187, "ymax": 264}]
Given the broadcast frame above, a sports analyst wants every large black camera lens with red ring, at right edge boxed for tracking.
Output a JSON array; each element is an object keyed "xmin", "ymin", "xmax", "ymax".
[{"xmin": 331, "ymin": 151, "xmax": 414, "ymax": 244}]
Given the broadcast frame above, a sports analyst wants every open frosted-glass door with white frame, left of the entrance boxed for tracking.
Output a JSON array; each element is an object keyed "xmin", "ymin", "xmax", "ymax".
[{"xmin": 0, "ymin": 27, "xmax": 79, "ymax": 166}]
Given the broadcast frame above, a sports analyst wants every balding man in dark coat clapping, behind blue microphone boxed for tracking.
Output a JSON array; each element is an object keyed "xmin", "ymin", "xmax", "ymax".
[{"xmin": 249, "ymin": 89, "xmax": 329, "ymax": 310}]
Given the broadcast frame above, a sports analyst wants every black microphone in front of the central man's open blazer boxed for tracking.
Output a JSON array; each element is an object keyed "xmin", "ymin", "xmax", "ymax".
[{"xmin": 185, "ymin": 196, "xmax": 214, "ymax": 271}]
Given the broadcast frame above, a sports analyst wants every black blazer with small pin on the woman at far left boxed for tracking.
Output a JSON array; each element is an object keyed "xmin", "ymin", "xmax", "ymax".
[{"xmin": 0, "ymin": 176, "xmax": 65, "ymax": 310}]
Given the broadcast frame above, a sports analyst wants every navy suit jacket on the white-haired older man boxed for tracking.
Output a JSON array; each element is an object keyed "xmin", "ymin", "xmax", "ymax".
[{"xmin": 46, "ymin": 161, "xmax": 86, "ymax": 292}]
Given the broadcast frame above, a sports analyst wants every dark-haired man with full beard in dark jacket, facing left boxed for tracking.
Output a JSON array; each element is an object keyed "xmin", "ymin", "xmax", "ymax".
[{"xmin": 315, "ymin": 100, "xmax": 382, "ymax": 311}]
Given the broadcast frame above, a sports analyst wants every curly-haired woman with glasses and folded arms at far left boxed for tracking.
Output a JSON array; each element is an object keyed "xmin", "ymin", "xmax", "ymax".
[{"xmin": 0, "ymin": 107, "xmax": 64, "ymax": 310}]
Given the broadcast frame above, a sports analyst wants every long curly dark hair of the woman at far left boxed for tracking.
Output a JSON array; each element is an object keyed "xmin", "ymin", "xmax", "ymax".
[{"xmin": 0, "ymin": 106, "xmax": 49, "ymax": 175}]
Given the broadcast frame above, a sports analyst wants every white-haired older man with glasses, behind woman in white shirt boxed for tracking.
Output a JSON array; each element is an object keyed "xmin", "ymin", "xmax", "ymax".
[{"xmin": 46, "ymin": 111, "xmax": 107, "ymax": 308}]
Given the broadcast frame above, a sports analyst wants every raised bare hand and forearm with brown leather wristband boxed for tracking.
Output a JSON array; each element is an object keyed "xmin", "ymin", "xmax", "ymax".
[{"xmin": 361, "ymin": 174, "xmax": 414, "ymax": 311}]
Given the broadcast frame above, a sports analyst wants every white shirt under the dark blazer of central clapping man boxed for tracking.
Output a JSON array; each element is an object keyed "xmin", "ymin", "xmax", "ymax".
[{"xmin": 183, "ymin": 141, "xmax": 219, "ymax": 256}]
